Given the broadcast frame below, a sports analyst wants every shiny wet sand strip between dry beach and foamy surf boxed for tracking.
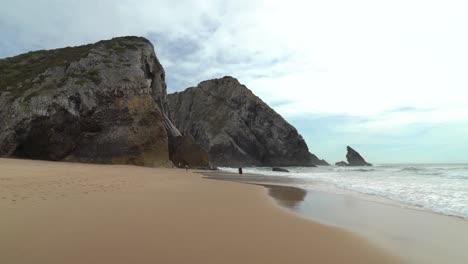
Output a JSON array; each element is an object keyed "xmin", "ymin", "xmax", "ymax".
[{"xmin": 205, "ymin": 172, "xmax": 468, "ymax": 264}]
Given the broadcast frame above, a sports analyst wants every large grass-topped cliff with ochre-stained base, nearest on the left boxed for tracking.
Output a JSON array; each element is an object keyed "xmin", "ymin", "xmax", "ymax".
[{"xmin": 0, "ymin": 37, "xmax": 176, "ymax": 166}]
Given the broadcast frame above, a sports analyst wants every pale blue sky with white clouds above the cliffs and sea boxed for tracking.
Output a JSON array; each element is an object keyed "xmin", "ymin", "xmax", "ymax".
[{"xmin": 0, "ymin": 0, "xmax": 468, "ymax": 163}]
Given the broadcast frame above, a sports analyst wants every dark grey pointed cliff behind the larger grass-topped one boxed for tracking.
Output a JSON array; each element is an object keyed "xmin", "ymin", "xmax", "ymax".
[{"xmin": 168, "ymin": 77, "xmax": 328, "ymax": 167}]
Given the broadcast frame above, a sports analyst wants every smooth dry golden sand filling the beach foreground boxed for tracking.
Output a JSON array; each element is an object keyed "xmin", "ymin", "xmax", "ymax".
[{"xmin": 0, "ymin": 159, "xmax": 399, "ymax": 264}]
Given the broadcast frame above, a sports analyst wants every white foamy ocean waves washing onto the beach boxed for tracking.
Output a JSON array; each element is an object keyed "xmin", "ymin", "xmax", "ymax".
[{"xmin": 220, "ymin": 164, "xmax": 468, "ymax": 220}]
